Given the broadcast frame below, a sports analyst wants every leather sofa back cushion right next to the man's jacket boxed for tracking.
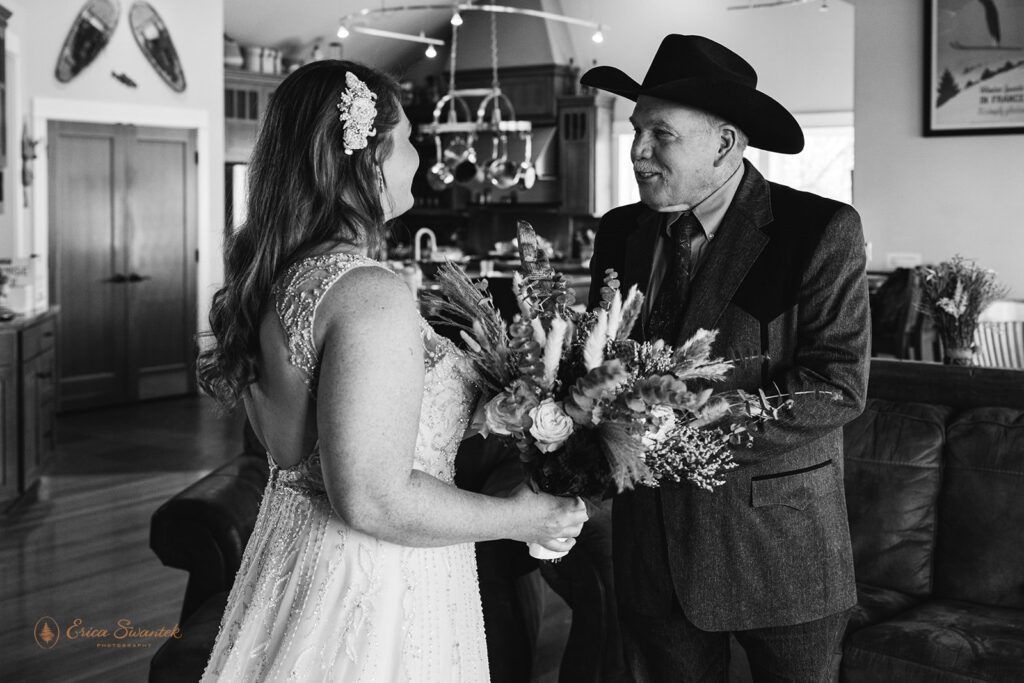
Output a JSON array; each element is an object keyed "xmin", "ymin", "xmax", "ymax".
[{"xmin": 843, "ymin": 398, "xmax": 951, "ymax": 596}]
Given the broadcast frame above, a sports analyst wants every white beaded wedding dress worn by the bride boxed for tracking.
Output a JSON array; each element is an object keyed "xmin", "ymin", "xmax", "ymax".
[{"xmin": 203, "ymin": 253, "xmax": 488, "ymax": 683}]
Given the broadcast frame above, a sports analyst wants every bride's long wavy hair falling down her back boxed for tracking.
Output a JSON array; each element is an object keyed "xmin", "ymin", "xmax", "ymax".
[{"xmin": 196, "ymin": 60, "xmax": 400, "ymax": 408}]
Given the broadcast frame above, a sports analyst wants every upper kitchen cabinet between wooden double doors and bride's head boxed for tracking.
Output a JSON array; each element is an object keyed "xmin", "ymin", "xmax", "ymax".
[{"xmin": 224, "ymin": 69, "xmax": 285, "ymax": 164}]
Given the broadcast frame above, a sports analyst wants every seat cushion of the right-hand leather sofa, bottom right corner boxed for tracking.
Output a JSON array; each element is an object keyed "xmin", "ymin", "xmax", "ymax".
[{"xmin": 843, "ymin": 600, "xmax": 1024, "ymax": 683}]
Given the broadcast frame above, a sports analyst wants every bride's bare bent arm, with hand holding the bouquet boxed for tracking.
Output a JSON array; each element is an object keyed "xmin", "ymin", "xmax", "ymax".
[{"xmin": 316, "ymin": 268, "xmax": 586, "ymax": 548}]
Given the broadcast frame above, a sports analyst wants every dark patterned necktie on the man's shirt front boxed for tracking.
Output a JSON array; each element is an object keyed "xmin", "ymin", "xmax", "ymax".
[{"xmin": 647, "ymin": 211, "xmax": 700, "ymax": 344}]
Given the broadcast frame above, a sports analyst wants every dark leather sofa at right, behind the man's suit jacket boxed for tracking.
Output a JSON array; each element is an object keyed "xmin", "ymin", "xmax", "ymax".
[{"xmin": 841, "ymin": 360, "xmax": 1024, "ymax": 683}]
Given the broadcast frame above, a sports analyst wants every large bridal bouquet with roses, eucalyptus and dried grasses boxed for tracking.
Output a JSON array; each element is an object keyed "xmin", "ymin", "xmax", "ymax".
[{"xmin": 433, "ymin": 221, "xmax": 792, "ymax": 516}]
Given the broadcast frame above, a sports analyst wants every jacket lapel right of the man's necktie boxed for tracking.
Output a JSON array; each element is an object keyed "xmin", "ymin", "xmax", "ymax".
[{"xmin": 675, "ymin": 160, "xmax": 772, "ymax": 345}]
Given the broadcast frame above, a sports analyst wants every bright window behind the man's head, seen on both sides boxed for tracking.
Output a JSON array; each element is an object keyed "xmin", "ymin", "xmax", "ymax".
[{"xmin": 614, "ymin": 112, "xmax": 853, "ymax": 206}]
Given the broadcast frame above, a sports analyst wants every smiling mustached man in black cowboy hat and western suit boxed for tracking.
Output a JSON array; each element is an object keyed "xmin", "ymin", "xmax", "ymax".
[{"xmin": 582, "ymin": 35, "xmax": 868, "ymax": 683}]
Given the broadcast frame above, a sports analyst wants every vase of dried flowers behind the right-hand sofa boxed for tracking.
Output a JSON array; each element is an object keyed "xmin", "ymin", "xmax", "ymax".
[{"xmin": 921, "ymin": 255, "xmax": 1007, "ymax": 366}]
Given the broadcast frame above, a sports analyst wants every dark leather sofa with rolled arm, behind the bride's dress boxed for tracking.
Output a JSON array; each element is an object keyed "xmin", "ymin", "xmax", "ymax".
[{"xmin": 148, "ymin": 425, "xmax": 544, "ymax": 683}]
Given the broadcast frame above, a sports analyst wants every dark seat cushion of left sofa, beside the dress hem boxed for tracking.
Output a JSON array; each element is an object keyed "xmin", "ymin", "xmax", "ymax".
[{"xmin": 150, "ymin": 591, "xmax": 228, "ymax": 683}]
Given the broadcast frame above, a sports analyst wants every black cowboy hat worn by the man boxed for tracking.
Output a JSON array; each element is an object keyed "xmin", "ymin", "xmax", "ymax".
[{"xmin": 580, "ymin": 34, "xmax": 804, "ymax": 155}]
